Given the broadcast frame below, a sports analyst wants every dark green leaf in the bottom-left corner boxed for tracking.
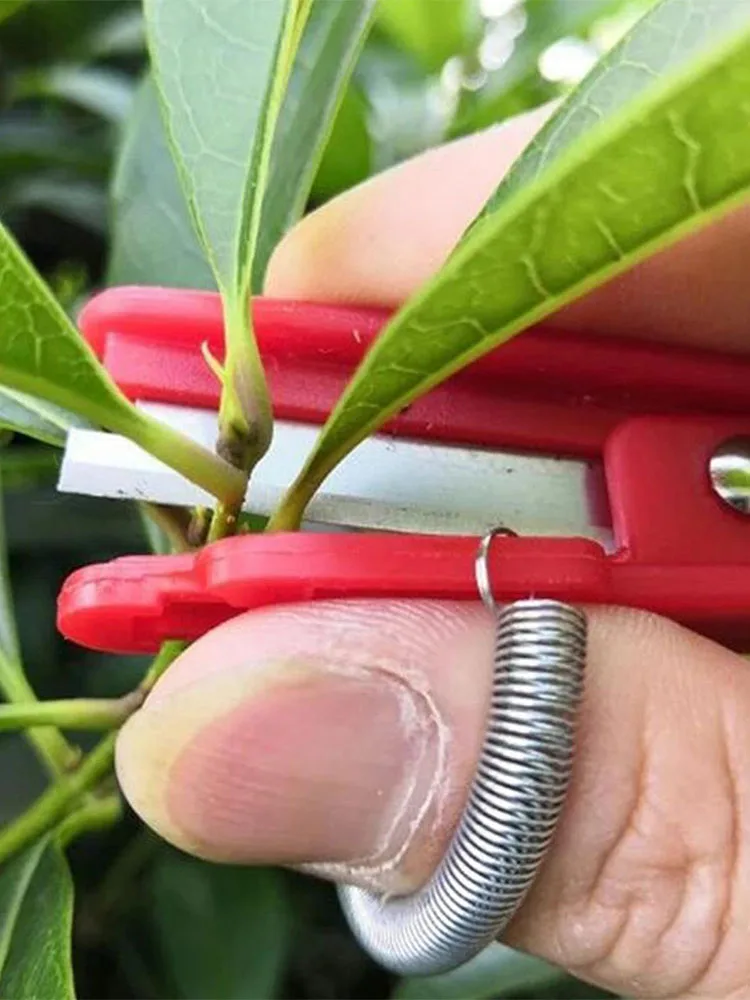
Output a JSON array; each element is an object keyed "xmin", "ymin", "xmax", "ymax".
[{"xmin": 0, "ymin": 840, "xmax": 75, "ymax": 1000}]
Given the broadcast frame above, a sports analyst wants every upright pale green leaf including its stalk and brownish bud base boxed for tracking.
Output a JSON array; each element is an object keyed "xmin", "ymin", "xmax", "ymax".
[{"xmin": 144, "ymin": 0, "xmax": 309, "ymax": 460}]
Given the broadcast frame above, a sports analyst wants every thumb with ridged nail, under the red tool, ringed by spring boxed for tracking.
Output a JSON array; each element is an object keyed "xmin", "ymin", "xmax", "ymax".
[{"xmin": 117, "ymin": 602, "xmax": 750, "ymax": 997}]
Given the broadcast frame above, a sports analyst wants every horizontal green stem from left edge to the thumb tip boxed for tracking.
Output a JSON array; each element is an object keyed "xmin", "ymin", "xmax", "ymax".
[{"xmin": 0, "ymin": 695, "xmax": 143, "ymax": 732}]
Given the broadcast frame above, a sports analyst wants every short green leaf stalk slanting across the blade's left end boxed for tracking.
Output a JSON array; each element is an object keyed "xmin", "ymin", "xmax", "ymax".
[{"xmin": 127, "ymin": 411, "xmax": 247, "ymax": 507}]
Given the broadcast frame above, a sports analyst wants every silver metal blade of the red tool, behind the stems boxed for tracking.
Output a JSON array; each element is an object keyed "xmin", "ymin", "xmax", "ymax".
[{"xmin": 59, "ymin": 403, "xmax": 611, "ymax": 545}]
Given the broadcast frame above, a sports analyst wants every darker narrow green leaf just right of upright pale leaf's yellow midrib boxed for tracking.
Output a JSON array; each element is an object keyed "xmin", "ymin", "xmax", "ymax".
[{"xmin": 253, "ymin": 0, "xmax": 376, "ymax": 291}]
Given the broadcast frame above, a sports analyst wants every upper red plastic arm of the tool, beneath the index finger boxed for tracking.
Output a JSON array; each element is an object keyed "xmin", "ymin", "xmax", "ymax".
[{"xmin": 80, "ymin": 288, "xmax": 750, "ymax": 457}]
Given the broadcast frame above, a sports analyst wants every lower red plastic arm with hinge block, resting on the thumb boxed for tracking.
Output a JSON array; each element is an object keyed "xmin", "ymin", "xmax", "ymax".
[{"xmin": 58, "ymin": 417, "xmax": 750, "ymax": 652}]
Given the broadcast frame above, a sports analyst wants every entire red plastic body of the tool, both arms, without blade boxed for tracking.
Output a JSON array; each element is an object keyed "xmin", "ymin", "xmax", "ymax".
[{"xmin": 58, "ymin": 290, "xmax": 750, "ymax": 652}]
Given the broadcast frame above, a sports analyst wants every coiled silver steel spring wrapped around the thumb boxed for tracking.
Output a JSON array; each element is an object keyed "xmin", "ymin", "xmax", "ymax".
[{"xmin": 339, "ymin": 600, "xmax": 586, "ymax": 976}]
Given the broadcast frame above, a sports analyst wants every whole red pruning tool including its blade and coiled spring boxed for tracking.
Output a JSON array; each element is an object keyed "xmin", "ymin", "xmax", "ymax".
[{"xmin": 58, "ymin": 287, "xmax": 750, "ymax": 973}]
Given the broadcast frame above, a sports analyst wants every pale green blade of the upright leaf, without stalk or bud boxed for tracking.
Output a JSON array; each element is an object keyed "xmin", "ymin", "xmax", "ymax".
[{"xmin": 145, "ymin": 0, "xmax": 296, "ymax": 295}]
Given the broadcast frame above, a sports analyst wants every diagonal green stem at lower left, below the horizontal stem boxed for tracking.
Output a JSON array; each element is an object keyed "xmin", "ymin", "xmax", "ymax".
[{"xmin": 0, "ymin": 733, "xmax": 117, "ymax": 864}]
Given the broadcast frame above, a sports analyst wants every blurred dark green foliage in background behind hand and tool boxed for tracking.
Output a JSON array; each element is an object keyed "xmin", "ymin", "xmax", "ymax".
[{"xmin": 0, "ymin": 0, "xmax": 648, "ymax": 1000}]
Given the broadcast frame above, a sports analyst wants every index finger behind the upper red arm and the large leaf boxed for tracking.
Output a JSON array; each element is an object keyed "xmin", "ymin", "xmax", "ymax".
[{"xmin": 266, "ymin": 107, "xmax": 750, "ymax": 352}]
